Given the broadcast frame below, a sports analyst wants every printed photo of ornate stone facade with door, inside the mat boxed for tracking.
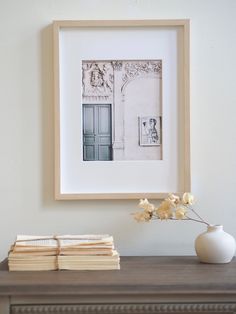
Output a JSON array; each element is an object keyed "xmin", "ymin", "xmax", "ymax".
[{"xmin": 82, "ymin": 60, "xmax": 162, "ymax": 161}]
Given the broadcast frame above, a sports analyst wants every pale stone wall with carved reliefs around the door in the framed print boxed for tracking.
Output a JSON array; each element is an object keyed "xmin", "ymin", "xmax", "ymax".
[{"xmin": 82, "ymin": 60, "xmax": 162, "ymax": 160}]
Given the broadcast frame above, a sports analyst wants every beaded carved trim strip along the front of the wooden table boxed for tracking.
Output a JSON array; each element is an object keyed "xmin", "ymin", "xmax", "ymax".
[{"xmin": 11, "ymin": 303, "xmax": 236, "ymax": 314}]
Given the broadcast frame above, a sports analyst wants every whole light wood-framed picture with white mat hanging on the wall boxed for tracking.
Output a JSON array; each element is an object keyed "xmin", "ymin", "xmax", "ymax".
[{"xmin": 53, "ymin": 20, "xmax": 190, "ymax": 200}]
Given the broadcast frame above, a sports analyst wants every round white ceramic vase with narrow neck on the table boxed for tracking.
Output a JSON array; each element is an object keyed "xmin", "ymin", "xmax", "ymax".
[{"xmin": 195, "ymin": 225, "xmax": 236, "ymax": 264}]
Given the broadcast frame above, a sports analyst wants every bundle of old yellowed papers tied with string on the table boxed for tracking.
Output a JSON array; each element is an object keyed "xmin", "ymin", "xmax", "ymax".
[{"xmin": 8, "ymin": 235, "xmax": 120, "ymax": 271}]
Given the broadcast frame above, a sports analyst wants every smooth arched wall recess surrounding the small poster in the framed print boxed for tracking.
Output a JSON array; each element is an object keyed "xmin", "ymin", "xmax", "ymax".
[{"xmin": 124, "ymin": 75, "xmax": 162, "ymax": 160}]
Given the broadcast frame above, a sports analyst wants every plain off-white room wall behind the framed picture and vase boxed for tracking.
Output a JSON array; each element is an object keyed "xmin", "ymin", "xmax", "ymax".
[{"xmin": 0, "ymin": 0, "xmax": 236, "ymax": 259}]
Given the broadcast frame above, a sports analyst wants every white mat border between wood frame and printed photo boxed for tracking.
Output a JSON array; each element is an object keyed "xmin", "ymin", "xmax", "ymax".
[{"xmin": 59, "ymin": 27, "xmax": 184, "ymax": 194}]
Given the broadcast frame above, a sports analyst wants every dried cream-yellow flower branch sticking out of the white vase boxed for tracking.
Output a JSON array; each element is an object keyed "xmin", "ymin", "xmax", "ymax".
[{"xmin": 133, "ymin": 193, "xmax": 210, "ymax": 226}]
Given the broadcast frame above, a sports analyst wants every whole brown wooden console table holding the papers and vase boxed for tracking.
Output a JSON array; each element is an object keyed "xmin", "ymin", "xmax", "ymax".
[{"xmin": 0, "ymin": 257, "xmax": 236, "ymax": 314}]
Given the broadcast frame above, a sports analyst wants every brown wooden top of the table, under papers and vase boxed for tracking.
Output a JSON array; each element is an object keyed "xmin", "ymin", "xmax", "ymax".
[{"xmin": 0, "ymin": 256, "xmax": 236, "ymax": 296}]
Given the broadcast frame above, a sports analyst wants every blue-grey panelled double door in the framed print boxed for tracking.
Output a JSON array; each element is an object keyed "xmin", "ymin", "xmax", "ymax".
[{"xmin": 83, "ymin": 104, "xmax": 112, "ymax": 161}]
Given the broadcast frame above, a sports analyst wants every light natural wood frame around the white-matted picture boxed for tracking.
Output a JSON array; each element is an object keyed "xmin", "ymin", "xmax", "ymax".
[{"xmin": 53, "ymin": 19, "xmax": 191, "ymax": 200}]
